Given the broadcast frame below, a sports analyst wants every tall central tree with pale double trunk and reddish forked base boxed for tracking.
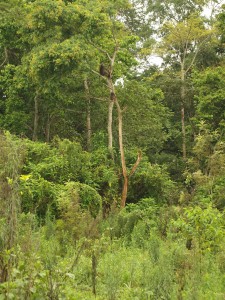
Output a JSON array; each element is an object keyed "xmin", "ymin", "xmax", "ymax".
[{"xmin": 82, "ymin": 1, "xmax": 141, "ymax": 207}]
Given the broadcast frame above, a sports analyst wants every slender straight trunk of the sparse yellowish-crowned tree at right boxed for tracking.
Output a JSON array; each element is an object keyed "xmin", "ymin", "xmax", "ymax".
[{"xmin": 180, "ymin": 66, "xmax": 187, "ymax": 160}]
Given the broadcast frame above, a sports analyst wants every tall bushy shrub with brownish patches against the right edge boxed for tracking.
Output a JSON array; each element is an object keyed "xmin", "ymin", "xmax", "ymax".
[{"xmin": 185, "ymin": 123, "xmax": 225, "ymax": 209}]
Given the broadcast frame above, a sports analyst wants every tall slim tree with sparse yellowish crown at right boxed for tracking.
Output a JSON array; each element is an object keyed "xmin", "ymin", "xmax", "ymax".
[{"xmin": 161, "ymin": 15, "xmax": 212, "ymax": 160}]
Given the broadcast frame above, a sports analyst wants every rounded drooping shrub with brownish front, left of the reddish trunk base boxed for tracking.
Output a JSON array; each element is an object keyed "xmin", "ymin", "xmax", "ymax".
[{"xmin": 56, "ymin": 182, "xmax": 101, "ymax": 243}]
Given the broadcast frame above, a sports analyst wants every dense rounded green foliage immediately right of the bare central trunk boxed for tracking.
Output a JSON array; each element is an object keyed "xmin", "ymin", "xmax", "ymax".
[{"xmin": 118, "ymin": 80, "xmax": 171, "ymax": 155}]
